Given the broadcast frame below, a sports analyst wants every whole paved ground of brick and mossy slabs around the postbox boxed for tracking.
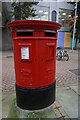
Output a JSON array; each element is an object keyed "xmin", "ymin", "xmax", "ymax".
[{"xmin": 0, "ymin": 50, "xmax": 80, "ymax": 119}]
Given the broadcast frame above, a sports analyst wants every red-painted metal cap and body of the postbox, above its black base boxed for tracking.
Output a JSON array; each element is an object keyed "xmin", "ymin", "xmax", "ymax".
[{"xmin": 8, "ymin": 20, "xmax": 60, "ymax": 88}]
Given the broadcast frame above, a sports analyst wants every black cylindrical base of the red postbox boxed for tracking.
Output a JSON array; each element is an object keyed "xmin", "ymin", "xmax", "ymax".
[{"xmin": 16, "ymin": 82, "xmax": 56, "ymax": 110}]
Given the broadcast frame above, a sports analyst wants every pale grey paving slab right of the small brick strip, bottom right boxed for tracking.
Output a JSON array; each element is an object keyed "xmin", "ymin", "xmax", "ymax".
[{"xmin": 56, "ymin": 87, "xmax": 78, "ymax": 118}]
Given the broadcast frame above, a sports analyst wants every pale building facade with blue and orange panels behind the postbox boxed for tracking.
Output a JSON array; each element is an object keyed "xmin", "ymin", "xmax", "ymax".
[{"xmin": 3, "ymin": 0, "xmax": 76, "ymax": 50}]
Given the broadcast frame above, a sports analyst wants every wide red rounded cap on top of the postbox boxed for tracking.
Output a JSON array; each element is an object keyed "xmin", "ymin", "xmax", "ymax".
[{"xmin": 8, "ymin": 20, "xmax": 61, "ymax": 30}]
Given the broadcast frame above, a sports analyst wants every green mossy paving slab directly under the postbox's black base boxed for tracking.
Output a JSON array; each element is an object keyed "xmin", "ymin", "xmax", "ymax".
[{"xmin": 8, "ymin": 103, "xmax": 56, "ymax": 118}]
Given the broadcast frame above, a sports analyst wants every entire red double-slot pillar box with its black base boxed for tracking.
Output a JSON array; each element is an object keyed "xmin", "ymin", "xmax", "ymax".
[{"xmin": 8, "ymin": 20, "xmax": 61, "ymax": 110}]
